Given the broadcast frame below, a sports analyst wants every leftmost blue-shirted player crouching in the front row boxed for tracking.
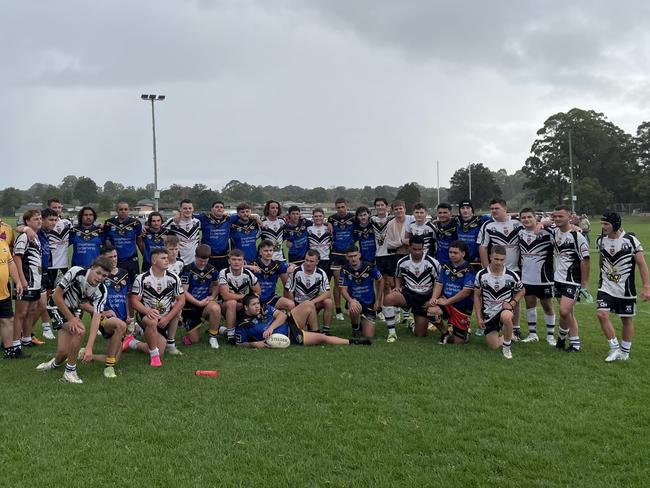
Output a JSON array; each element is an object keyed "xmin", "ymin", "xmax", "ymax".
[{"xmin": 79, "ymin": 246, "xmax": 130, "ymax": 378}]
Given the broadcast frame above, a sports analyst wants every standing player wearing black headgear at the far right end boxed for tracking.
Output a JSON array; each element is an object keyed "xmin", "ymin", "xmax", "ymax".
[{"xmin": 596, "ymin": 212, "xmax": 650, "ymax": 363}]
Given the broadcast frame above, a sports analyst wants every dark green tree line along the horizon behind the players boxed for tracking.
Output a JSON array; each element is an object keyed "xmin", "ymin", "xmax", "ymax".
[{"xmin": 0, "ymin": 108, "xmax": 650, "ymax": 215}]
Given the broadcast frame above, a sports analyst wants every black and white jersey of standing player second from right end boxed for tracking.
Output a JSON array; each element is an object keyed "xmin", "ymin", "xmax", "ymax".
[{"xmin": 549, "ymin": 228, "xmax": 589, "ymax": 286}]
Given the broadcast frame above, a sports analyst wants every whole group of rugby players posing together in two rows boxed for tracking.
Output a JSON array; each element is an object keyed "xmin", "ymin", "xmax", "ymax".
[{"xmin": 0, "ymin": 198, "xmax": 650, "ymax": 383}]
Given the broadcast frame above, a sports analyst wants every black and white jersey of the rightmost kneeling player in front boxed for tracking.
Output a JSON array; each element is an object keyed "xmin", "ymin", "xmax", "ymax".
[{"xmin": 474, "ymin": 267, "xmax": 524, "ymax": 322}]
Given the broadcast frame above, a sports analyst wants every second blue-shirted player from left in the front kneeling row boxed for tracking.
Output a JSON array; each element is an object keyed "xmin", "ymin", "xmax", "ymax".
[{"xmin": 181, "ymin": 244, "xmax": 221, "ymax": 349}]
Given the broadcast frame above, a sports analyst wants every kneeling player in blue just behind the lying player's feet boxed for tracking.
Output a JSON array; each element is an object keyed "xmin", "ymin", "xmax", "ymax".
[{"xmin": 340, "ymin": 246, "xmax": 384, "ymax": 338}]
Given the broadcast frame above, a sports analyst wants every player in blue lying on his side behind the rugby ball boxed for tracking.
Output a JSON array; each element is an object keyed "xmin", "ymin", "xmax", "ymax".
[{"xmin": 235, "ymin": 293, "xmax": 370, "ymax": 349}]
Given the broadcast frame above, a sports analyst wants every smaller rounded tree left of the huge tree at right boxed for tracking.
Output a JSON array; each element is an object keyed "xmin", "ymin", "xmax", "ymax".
[{"xmin": 448, "ymin": 163, "xmax": 498, "ymax": 208}]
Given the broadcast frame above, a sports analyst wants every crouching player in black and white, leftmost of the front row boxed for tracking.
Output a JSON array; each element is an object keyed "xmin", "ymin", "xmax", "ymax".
[{"xmin": 36, "ymin": 256, "xmax": 113, "ymax": 384}]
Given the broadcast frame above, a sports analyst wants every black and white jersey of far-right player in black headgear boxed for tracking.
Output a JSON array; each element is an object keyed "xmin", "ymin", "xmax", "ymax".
[{"xmin": 596, "ymin": 231, "xmax": 643, "ymax": 298}]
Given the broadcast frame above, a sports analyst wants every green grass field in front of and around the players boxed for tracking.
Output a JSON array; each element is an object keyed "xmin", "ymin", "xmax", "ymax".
[{"xmin": 0, "ymin": 219, "xmax": 650, "ymax": 487}]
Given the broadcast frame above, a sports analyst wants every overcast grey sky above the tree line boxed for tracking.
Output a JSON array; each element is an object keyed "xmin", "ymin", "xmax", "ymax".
[{"xmin": 0, "ymin": 0, "xmax": 650, "ymax": 189}]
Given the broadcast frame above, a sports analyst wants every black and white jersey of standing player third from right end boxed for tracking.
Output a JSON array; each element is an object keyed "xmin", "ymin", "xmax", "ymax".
[{"xmin": 519, "ymin": 228, "xmax": 553, "ymax": 285}]
